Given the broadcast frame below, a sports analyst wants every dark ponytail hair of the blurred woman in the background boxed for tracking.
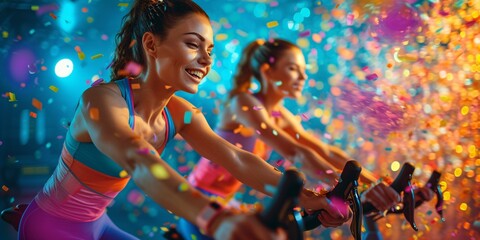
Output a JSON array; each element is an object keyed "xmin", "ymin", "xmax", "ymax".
[{"xmin": 228, "ymin": 38, "xmax": 299, "ymax": 99}]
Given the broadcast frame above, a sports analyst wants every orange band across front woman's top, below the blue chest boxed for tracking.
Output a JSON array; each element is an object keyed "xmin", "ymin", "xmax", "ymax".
[{"xmin": 62, "ymin": 145, "xmax": 130, "ymax": 195}]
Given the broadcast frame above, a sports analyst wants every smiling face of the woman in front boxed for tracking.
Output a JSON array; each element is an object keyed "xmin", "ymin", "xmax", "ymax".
[{"xmin": 154, "ymin": 14, "xmax": 213, "ymax": 93}]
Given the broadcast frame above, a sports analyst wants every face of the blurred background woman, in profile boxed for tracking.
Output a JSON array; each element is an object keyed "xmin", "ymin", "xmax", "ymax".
[{"xmin": 267, "ymin": 48, "xmax": 307, "ymax": 98}]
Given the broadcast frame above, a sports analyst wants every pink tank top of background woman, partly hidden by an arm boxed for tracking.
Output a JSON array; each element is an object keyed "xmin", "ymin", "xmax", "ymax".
[{"xmin": 188, "ymin": 130, "xmax": 266, "ymax": 198}]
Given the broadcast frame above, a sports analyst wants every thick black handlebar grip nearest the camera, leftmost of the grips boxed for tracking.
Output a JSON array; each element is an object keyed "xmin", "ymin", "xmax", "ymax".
[{"xmin": 259, "ymin": 169, "xmax": 303, "ymax": 230}]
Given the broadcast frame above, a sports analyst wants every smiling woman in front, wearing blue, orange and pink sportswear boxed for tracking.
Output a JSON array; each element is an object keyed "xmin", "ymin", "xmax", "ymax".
[{"xmin": 13, "ymin": 0, "xmax": 349, "ymax": 239}]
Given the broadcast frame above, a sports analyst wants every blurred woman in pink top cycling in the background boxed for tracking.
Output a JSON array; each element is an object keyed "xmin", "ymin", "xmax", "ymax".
[{"xmin": 183, "ymin": 39, "xmax": 433, "ymax": 239}]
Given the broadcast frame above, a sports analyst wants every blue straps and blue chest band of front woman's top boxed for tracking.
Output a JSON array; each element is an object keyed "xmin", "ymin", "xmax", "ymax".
[{"xmin": 65, "ymin": 78, "xmax": 176, "ymax": 177}]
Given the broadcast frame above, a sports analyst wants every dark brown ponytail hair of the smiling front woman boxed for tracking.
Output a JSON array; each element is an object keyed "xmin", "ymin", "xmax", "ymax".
[{"xmin": 110, "ymin": 0, "xmax": 210, "ymax": 80}]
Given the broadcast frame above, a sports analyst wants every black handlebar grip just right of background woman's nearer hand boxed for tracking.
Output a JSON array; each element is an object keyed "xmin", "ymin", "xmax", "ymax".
[{"xmin": 363, "ymin": 162, "xmax": 418, "ymax": 231}]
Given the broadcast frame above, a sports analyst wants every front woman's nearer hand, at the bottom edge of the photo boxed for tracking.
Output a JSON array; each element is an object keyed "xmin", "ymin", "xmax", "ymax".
[{"xmin": 212, "ymin": 212, "xmax": 287, "ymax": 240}]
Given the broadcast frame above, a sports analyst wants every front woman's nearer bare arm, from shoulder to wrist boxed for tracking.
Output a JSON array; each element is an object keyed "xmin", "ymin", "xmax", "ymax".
[{"xmin": 79, "ymin": 85, "xmax": 216, "ymax": 225}]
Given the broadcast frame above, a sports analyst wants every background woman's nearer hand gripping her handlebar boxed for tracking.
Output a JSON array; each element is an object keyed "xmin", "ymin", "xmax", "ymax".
[{"xmin": 360, "ymin": 183, "xmax": 401, "ymax": 212}]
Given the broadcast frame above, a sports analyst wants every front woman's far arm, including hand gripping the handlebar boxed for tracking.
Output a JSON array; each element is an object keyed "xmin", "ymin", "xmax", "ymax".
[{"xmin": 171, "ymin": 98, "xmax": 350, "ymax": 227}]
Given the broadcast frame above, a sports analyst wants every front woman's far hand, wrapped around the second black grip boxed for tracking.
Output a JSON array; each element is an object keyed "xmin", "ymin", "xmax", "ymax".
[{"xmin": 300, "ymin": 189, "xmax": 352, "ymax": 227}]
